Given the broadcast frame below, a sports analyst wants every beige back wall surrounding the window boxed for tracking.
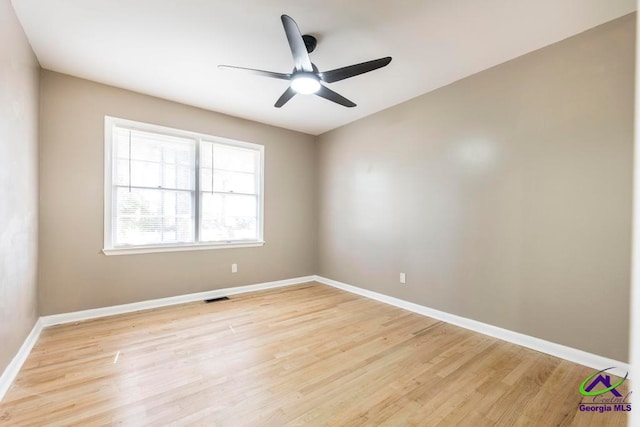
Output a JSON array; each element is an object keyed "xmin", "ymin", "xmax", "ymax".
[{"xmin": 39, "ymin": 71, "xmax": 316, "ymax": 315}]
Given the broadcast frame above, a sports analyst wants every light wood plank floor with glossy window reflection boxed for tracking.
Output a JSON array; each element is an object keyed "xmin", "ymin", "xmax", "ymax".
[{"xmin": 0, "ymin": 283, "xmax": 626, "ymax": 427}]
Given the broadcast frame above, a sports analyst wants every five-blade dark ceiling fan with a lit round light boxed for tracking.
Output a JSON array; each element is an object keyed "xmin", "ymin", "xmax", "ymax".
[{"xmin": 218, "ymin": 15, "xmax": 391, "ymax": 108}]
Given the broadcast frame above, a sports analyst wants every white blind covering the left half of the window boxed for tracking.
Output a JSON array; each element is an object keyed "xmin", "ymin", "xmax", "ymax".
[{"xmin": 112, "ymin": 127, "xmax": 196, "ymax": 246}]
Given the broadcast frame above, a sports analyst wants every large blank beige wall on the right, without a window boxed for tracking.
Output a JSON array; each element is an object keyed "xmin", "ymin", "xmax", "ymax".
[{"xmin": 318, "ymin": 15, "xmax": 635, "ymax": 361}]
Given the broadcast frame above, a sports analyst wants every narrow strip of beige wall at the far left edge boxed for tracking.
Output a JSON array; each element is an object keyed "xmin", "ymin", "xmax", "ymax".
[{"xmin": 0, "ymin": 0, "xmax": 39, "ymax": 375}]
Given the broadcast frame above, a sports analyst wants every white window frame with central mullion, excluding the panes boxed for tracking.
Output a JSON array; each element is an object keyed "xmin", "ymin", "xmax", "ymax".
[{"xmin": 102, "ymin": 116, "xmax": 265, "ymax": 255}]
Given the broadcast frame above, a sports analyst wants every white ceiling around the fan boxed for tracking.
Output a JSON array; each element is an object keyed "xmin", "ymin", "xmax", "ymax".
[{"xmin": 8, "ymin": 0, "xmax": 636, "ymax": 135}]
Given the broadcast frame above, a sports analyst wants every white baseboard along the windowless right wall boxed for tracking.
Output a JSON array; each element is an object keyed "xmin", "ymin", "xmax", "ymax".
[{"xmin": 315, "ymin": 276, "xmax": 630, "ymax": 377}]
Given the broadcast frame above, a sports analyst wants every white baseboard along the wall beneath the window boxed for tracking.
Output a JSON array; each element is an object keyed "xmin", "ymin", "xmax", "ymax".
[{"xmin": 40, "ymin": 276, "xmax": 315, "ymax": 327}]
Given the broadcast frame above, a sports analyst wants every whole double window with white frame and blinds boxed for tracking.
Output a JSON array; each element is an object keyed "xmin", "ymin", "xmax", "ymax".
[{"xmin": 104, "ymin": 117, "xmax": 264, "ymax": 255}]
